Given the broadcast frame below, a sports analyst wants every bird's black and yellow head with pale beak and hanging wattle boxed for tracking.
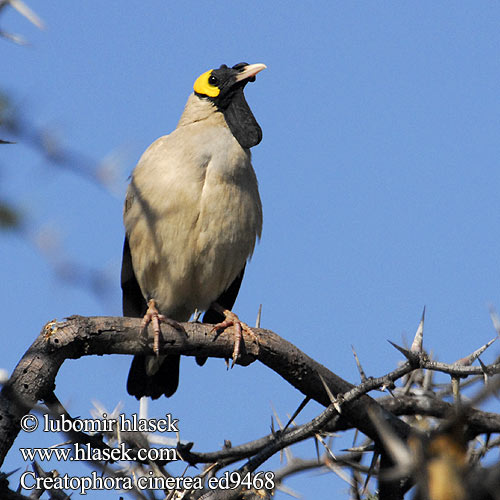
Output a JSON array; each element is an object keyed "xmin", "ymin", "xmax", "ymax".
[{"xmin": 194, "ymin": 63, "xmax": 266, "ymax": 148}]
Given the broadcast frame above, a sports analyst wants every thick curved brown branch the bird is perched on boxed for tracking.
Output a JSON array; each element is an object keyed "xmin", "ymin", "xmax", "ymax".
[{"xmin": 0, "ymin": 316, "xmax": 410, "ymax": 464}]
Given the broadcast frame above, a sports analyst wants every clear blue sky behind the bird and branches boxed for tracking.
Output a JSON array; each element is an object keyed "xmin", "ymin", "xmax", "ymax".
[{"xmin": 0, "ymin": 0, "xmax": 500, "ymax": 498}]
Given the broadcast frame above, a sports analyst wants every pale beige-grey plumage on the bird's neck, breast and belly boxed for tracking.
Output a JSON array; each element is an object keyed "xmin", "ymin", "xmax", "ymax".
[{"xmin": 124, "ymin": 94, "xmax": 262, "ymax": 321}]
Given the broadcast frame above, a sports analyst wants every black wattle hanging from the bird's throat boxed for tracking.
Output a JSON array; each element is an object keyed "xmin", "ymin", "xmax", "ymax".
[{"xmin": 222, "ymin": 89, "xmax": 262, "ymax": 149}]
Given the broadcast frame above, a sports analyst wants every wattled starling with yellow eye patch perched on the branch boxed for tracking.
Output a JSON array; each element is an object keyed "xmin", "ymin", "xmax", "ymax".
[{"xmin": 121, "ymin": 63, "xmax": 266, "ymax": 399}]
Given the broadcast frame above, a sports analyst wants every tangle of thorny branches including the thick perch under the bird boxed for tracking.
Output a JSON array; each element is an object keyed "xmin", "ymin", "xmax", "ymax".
[{"xmin": 0, "ymin": 316, "xmax": 500, "ymax": 500}]
